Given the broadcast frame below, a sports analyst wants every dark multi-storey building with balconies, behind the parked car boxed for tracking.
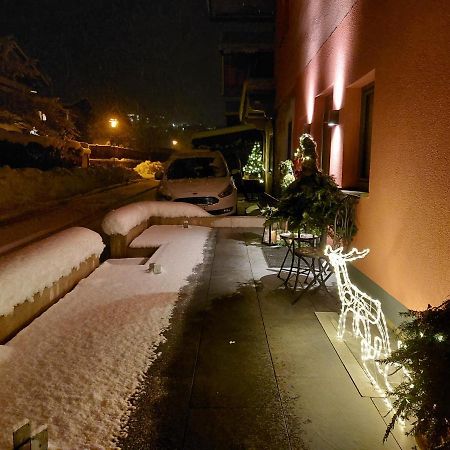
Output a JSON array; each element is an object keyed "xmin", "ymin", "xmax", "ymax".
[{"xmin": 204, "ymin": 0, "xmax": 275, "ymax": 191}]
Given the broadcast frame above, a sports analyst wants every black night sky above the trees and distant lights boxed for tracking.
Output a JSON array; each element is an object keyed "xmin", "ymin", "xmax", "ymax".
[{"xmin": 0, "ymin": 0, "xmax": 229, "ymax": 126}]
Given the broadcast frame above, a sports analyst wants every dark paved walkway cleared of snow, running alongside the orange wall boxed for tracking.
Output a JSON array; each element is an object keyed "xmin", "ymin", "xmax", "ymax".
[{"xmin": 120, "ymin": 229, "xmax": 412, "ymax": 450}]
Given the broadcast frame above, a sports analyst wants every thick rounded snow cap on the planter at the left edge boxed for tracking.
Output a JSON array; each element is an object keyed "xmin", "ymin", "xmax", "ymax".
[{"xmin": 0, "ymin": 227, "xmax": 105, "ymax": 315}]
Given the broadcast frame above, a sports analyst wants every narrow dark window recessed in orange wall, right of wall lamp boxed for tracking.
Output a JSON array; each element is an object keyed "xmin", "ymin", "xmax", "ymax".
[{"xmin": 359, "ymin": 83, "xmax": 375, "ymax": 188}]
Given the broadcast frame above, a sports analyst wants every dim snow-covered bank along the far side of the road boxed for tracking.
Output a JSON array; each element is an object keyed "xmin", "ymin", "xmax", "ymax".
[{"xmin": 0, "ymin": 166, "xmax": 140, "ymax": 220}]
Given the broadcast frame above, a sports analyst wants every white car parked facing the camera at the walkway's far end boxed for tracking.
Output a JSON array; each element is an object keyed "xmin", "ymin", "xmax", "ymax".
[{"xmin": 155, "ymin": 150, "xmax": 237, "ymax": 215}]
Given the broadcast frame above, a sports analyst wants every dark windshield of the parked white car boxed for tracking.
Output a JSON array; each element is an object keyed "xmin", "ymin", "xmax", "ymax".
[{"xmin": 167, "ymin": 157, "xmax": 227, "ymax": 180}]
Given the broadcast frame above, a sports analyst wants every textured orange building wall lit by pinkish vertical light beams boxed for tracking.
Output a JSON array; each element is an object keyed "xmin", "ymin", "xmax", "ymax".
[{"xmin": 276, "ymin": 0, "xmax": 450, "ymax": 309}]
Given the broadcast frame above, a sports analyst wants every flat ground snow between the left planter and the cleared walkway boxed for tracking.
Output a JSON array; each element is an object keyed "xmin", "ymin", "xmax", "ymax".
[{"xmin": 0, "ymin": 225, "xmax": 210, "ymax": 449}]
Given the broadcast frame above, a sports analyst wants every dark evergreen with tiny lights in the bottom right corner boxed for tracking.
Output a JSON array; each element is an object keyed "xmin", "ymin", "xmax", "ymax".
[{"xmin": 383, "ymin": 299, "xmax": 450, "ymax": 449}]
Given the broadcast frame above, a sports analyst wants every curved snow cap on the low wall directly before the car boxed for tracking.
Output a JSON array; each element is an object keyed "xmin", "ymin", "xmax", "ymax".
[{"xmin": 102, "ymin": 201, "xmax": 211, "ymax": 236}]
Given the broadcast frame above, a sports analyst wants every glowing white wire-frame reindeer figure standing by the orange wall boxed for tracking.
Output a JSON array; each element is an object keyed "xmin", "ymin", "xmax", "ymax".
[{"xmin": 324, "ymin": 245, "xmax": 391, "ymax": 386}]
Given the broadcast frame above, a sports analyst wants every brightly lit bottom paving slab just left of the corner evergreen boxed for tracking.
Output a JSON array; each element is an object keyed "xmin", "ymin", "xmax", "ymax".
[{"xmin": 279, "ymin": 372, "xmax": 399, "ymax": 450}]
